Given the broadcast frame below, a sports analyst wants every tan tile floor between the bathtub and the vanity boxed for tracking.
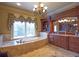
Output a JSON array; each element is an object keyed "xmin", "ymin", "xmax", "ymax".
[{"xmin": 21, "ymin": 44, "xmax": 79, "ymax": 57}]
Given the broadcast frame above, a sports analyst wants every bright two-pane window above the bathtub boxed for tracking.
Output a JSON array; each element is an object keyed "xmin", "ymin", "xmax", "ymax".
[{"xmin": 13, "ymin": 21, "xmax": 35, "ymax": 38}]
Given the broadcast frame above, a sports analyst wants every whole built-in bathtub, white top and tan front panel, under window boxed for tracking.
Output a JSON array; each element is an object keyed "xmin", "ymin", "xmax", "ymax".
[{"xmin": 0, "ymin": 37, "xmax": 48, "ymax": 56}]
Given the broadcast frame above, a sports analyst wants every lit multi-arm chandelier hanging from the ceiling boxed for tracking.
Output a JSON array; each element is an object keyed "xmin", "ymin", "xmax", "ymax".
[{"xmin": 33, "ymin": 2, "xmax": 47, "ymax": 15}]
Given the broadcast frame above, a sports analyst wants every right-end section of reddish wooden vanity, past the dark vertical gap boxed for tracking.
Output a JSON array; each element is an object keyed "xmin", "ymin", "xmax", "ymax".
[{"xmin": 69, "ymin": 37, "xmax": 79, "ymax": 53}]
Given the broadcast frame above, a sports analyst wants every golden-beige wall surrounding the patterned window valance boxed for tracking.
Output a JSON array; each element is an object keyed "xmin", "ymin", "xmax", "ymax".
[{"xmin": 0, "ymin": 5, "xmax": 41, "ymax": 37}]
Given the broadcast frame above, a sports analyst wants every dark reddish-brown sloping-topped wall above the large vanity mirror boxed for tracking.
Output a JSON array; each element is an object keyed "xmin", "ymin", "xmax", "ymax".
[{"xmin": 56, "ymin": 6, "xmax": 79, "ymax": 19}]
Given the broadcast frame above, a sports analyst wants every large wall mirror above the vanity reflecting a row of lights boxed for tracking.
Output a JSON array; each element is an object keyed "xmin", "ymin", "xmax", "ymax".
[{"xmin": 58, "ymin": 17, "xmax": 78, "ymax": 33}]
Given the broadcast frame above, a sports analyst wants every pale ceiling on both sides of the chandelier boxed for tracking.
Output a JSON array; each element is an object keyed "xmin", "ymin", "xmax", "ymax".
[{"xmin": 0, "ymin": 2, "xmax": 79, "ymax": 15}]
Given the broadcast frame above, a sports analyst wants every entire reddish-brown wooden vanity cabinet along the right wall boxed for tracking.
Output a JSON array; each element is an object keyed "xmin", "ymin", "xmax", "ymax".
[{"xmin": 48, "ymin": 34, "xmax": 79, "ymax": 53}]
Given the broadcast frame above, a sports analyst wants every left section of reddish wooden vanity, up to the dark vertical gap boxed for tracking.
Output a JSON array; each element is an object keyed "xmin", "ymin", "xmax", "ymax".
[{"xmin": 48, "ymin": 35, "xmax": 68, "ymax": 49}]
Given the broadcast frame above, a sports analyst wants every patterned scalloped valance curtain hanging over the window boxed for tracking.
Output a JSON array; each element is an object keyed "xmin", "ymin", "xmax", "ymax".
[{"xmin": 8, "ymin": 13, "xmax": 37, "ymax": 31}]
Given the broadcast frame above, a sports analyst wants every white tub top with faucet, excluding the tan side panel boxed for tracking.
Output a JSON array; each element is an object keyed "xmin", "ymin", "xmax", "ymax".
[{"xmin": 0, "ymin": 37, "xmax": 47, "ymax": 47}]
